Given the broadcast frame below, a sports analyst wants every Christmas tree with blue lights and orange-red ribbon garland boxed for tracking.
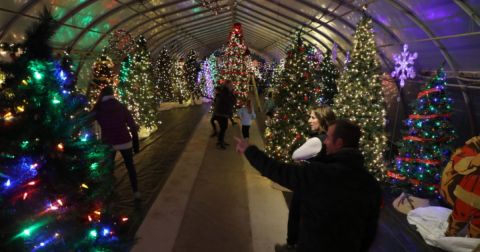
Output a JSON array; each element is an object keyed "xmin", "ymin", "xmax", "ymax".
[{"xmin": 388, "ymin": 69, "xmax": 455, "ymax": 198}]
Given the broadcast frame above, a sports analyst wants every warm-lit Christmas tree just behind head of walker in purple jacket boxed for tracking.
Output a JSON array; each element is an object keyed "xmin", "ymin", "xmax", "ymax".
[{"xmin": 87, "ymin": 53, "xmax": 117, "ymax": 107}]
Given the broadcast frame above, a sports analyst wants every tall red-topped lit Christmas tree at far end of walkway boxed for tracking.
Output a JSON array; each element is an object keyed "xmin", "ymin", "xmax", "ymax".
[{"xmin": 220, "ymin": 23, "xmax": 248, "ymax": 104}]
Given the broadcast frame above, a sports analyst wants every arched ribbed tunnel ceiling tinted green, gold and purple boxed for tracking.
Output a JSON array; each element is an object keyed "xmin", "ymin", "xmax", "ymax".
[{"xmin": 0, "ymin": 0, "xmax": 480, "ymax": 75}]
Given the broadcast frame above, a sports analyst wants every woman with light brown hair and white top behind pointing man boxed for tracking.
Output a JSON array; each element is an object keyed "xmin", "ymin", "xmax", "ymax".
[{"xmin": 276, "ymin": 105, "xmax": 336, "ymax": 251}]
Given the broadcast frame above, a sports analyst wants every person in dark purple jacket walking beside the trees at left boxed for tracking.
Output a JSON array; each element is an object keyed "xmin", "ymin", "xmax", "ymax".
[{"xmin": 93, "ymin": 86, "xmax": 140, "ymax": 199}]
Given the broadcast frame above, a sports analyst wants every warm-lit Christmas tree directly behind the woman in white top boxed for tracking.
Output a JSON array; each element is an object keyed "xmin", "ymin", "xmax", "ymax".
[{"xmin": 265, "ymin": 35, "xmax": 315, "ymax": 162}]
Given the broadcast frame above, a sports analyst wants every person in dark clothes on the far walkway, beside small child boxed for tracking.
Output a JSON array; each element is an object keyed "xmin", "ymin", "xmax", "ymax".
[{"xmin": 213, "ymin": 81, "xmax": 236, "ymax": 149}]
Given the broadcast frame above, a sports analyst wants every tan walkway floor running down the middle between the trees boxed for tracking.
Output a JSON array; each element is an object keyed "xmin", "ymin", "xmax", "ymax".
[{"xmin": 133, "ymin": 114, "xmax": 288, "ymax": 252}]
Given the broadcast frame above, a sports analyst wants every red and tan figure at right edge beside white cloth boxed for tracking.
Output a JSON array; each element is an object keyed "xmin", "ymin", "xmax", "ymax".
[{"xmin": 440, "ymin": 136, "xmax": 480, "ymax": 238}]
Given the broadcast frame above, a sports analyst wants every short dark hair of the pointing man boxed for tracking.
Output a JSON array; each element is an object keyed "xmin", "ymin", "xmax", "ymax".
[{"xmin": 330, "ymin": 119, "xmax": 362, "ymax": 148}]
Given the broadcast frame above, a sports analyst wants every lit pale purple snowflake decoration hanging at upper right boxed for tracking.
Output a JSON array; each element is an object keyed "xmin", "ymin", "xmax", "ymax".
[{"xmin": 391, "ymin": 44, "xmax": 418, "ymax": 87}]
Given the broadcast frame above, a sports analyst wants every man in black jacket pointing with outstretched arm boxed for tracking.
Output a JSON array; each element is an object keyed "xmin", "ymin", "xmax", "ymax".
[{"xmin": 236, "ymin": 120, "xmax": 381, "ymax": 252}]
